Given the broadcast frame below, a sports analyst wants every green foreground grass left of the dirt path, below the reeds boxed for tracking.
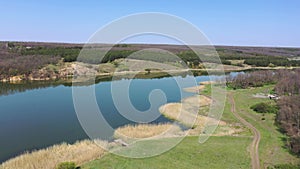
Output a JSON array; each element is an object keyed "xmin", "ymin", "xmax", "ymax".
[{"xmin": 82, "ymin": 136, "xmax": 251, "ymax": 169}]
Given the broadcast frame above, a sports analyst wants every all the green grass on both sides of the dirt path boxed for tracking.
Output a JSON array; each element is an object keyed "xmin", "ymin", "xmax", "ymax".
[{"xmin": 82, "ymin": 85, "xmax": 300, "ymax": 169}]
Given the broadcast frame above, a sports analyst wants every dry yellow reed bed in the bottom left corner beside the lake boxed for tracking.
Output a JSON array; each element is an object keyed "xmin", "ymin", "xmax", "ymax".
[{"xmin": 0, "ymin": 140, "xmax": 105, "ymax": 169}]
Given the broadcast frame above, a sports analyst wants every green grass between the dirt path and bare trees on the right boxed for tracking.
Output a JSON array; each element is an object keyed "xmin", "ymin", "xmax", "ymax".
[{"xmin": 232, "ymin": 85, "xmax": 300, "ymax": 167}]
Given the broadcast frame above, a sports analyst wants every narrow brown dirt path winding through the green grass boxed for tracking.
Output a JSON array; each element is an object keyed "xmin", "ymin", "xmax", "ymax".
[{"xmin": 228, "ymin": 93, "xmax": 260, "ymax": 169}]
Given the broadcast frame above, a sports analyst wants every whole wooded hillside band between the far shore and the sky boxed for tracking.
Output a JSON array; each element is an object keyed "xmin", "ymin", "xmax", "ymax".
[{"xmin": 0, "ymin": 42, "xmax": 300, "ymax": 79}]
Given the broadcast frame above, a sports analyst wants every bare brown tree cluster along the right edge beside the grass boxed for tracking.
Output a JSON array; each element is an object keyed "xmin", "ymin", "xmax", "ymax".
[{"xmin": 275, "ymin": 69, "xmax": 300, "ymax": 155}]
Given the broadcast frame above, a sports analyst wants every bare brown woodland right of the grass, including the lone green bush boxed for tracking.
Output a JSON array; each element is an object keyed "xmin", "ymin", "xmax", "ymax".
[{"xmin": 227, "ymin": 69, "xmax": 300, "ymax": 155}]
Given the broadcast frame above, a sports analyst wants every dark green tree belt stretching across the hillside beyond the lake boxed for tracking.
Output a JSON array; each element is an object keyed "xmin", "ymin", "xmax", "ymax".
[{"xmin": 20, "ymin": 45, "xmax": 300, "ymax": 67}]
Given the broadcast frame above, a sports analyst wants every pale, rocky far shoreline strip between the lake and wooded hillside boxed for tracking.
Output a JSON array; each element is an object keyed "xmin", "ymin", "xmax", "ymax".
[{"xmin": 0, "ymin": 67, "xmax": 299, "ymax": 84}]
